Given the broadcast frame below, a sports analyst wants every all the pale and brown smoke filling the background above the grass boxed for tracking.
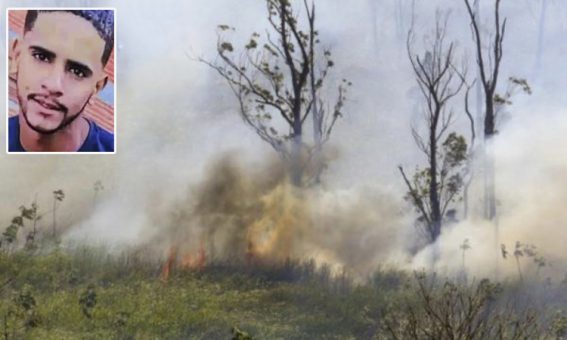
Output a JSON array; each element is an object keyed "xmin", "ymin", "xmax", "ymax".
[{"xmin": 0, "ymin": 0, "xmax": 567, "ymax": 282}]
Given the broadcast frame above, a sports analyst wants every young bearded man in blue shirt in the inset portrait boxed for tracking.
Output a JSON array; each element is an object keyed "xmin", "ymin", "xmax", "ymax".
[{"xmin": 8, "ymin": 10, "xmax": 114, "ymax": 152}]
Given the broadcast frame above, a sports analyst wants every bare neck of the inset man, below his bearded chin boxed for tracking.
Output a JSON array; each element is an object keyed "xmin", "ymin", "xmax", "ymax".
[{"xmin": 19, "ymin": 114, "xmax": 90, "ymax": 152}]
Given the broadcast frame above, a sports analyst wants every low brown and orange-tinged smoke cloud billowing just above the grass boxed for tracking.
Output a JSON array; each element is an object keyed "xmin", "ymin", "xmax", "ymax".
[{"xmin": 122, "ymin": 154, "xmax": 408, "ymax": 275}]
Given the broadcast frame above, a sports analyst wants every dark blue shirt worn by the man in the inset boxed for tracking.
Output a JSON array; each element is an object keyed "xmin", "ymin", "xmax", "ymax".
[{"xmin": 8, "ymin": 116, "xmax": 114, "ymax": 152}]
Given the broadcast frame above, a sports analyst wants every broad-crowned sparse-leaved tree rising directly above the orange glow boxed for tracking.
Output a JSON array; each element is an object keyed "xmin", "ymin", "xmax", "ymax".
[{"xmin": 200, "ymin": 0, "xmax": 350, "ymax": 186}]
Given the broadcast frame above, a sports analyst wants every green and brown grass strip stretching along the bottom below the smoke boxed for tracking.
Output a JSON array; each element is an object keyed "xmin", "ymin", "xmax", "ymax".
[{"xmin": 0, "ymin": 247, "xmax": 567, "ymax": 339}]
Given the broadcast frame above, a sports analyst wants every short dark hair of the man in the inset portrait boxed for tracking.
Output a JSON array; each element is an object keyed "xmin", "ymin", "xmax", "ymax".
[{"xmin": 24, "ymin": 10, "xmax": 114, "ymax": 66}]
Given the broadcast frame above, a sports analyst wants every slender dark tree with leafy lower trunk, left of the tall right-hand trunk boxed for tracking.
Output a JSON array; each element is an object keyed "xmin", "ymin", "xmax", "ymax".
[{"xmin": 399, "ymin": 13, "xmax": 467, "ymax": 242}]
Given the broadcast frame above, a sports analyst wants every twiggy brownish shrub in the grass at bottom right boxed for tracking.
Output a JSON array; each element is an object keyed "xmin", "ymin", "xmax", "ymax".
[{"xmin": 383, "ymin": 273, "xmax": 545, "ymax": 340}]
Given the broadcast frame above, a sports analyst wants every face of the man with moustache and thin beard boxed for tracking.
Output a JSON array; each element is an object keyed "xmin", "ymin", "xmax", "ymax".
[{"xmin": 14, "ymin": 12, "xmax": 106, "ymax": 134}]
